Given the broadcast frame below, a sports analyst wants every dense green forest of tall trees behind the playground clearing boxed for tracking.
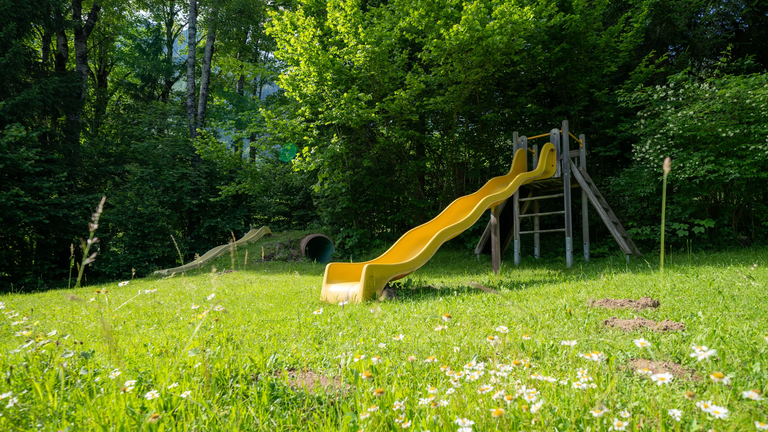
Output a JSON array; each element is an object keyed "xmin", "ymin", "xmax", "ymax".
[{"xmin": 0, "ymin": 0, "xmax": 768, "ymax": 291}]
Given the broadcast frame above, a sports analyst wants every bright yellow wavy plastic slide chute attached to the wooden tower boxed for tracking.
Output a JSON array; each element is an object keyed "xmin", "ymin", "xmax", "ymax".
[{"xmin": 322, "ymin": 143, "xmax": 556, "ymax": 303}]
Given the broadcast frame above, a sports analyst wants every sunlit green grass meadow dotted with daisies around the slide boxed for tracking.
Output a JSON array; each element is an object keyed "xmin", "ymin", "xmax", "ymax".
[{"xmin": 0, "ymin": 245, "xmax": 768, "ymax": 431}]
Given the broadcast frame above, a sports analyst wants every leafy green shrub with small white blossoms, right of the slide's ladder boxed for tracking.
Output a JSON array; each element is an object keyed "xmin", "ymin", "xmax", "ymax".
[{"xmin": 620, "ymin": 64, "xmax": 768, "ymax": 244}]
